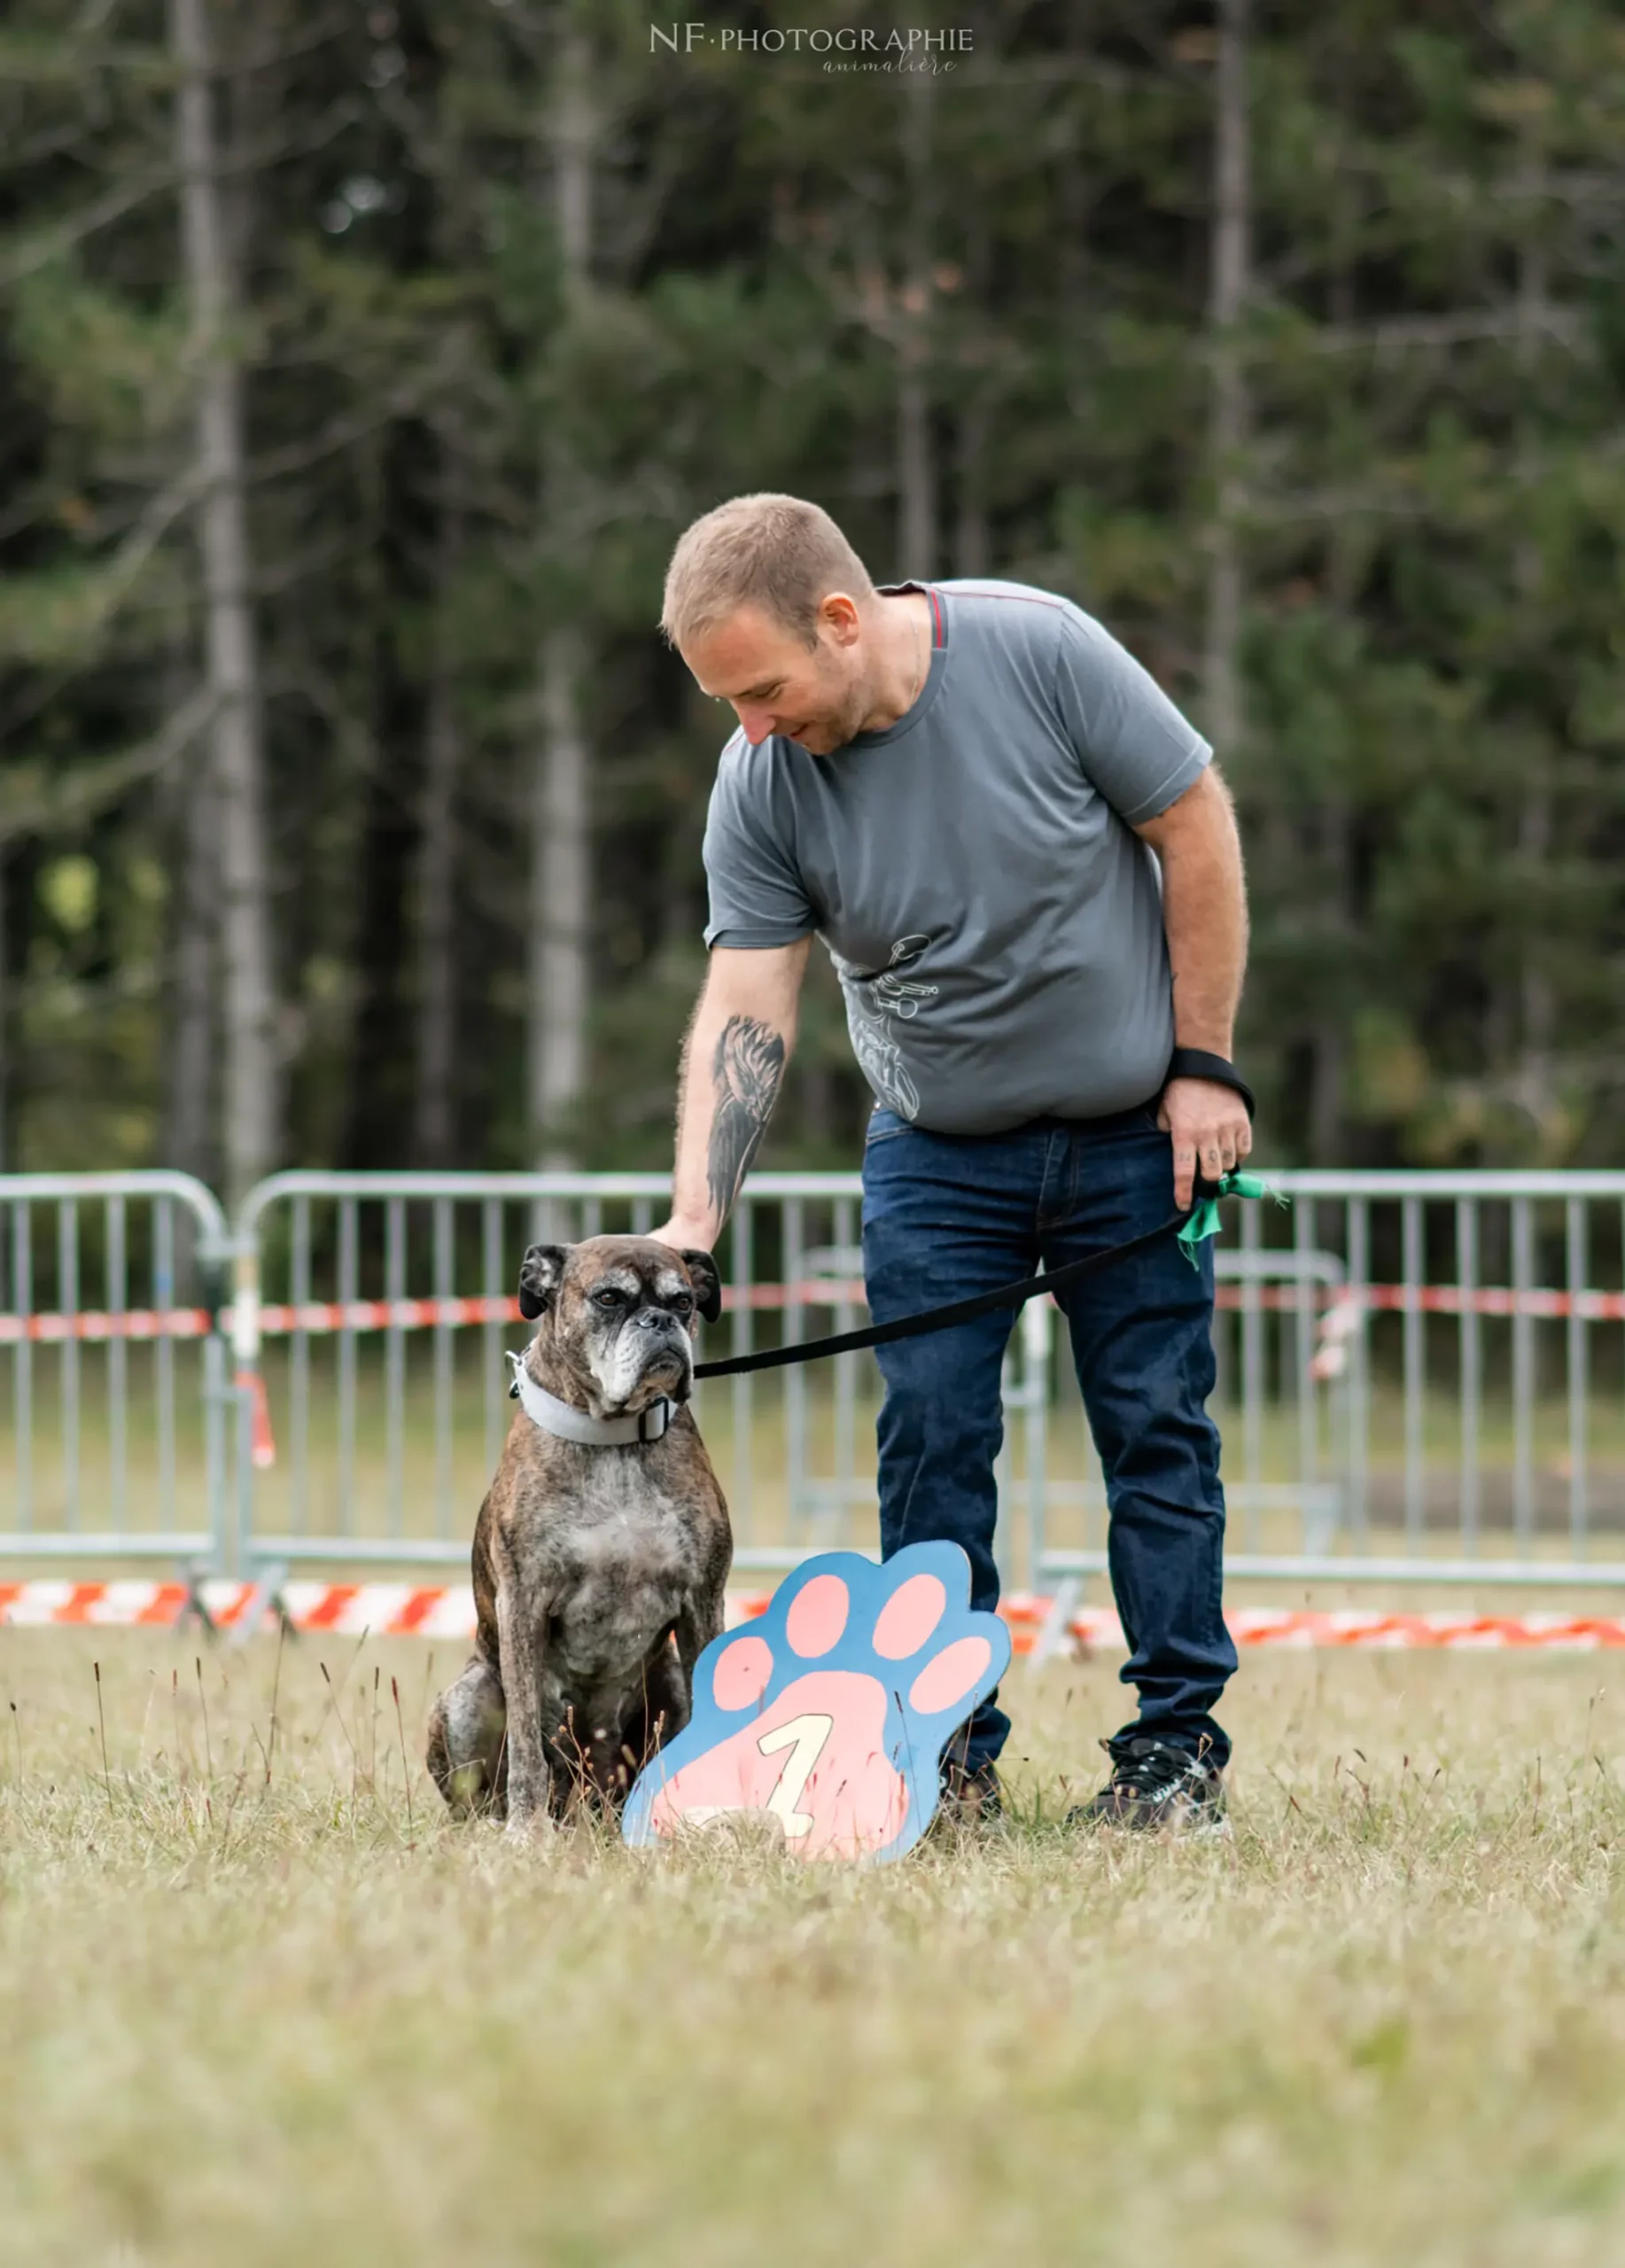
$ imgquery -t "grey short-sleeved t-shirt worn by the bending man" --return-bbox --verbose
[706,580,1212,1134]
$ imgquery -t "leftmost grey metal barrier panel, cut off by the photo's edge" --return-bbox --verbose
[0,1173,236,1560]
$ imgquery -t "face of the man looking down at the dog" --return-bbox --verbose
[683,592,869,755]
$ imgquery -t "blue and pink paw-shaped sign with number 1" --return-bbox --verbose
[622,1542,1010,1860]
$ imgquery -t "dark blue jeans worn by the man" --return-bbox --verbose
[862,1105,1234,1767]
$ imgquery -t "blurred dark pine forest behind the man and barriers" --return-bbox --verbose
[0,0,1625,1191]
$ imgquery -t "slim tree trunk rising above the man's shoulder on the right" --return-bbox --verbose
[1203,0,1250,757]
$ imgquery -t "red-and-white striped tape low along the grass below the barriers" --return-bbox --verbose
[0,1579,1625,1653]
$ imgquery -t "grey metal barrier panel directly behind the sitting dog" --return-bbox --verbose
[234,1173,903,1567]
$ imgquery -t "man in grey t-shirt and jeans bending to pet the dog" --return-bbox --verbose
[658,494,1250,1830]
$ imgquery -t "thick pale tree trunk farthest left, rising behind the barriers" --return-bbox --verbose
[170,0,279,1202]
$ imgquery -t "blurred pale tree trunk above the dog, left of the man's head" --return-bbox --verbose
[526,25,599,1170]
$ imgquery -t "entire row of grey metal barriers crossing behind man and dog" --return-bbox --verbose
[0,1173,1625,1590]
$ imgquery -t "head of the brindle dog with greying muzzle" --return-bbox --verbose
[520,1236,722,1418]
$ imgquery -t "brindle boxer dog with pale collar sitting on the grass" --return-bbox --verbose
[429,1236,733,1832]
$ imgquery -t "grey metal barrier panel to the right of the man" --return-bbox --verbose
[1030,1173,1625,1611]
